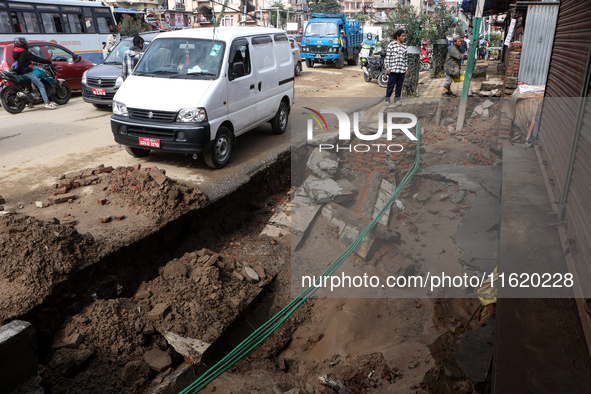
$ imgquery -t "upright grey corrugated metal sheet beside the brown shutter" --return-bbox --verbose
[519,4,558,85]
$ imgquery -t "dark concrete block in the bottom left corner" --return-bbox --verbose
[0,320,37,393]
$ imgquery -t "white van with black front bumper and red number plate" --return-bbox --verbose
[111,27,294,168]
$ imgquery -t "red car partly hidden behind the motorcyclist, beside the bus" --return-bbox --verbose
[0,41,94,90]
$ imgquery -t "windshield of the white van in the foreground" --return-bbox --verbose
[133,38,225,79]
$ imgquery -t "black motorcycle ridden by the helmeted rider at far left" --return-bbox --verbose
[0,64,72,114]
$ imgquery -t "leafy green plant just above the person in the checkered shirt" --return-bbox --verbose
[382,2,427,46]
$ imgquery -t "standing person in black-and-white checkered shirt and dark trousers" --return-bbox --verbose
[384,29,408,105]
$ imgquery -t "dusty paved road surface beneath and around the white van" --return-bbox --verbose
[0,85,376,207]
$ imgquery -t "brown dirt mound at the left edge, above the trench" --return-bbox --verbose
[0,214,99,322]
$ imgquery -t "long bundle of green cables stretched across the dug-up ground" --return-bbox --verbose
[179,121,421,394]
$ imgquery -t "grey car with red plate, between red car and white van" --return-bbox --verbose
[82,32,160,108]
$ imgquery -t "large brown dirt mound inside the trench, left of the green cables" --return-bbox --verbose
[43,242,289,393]
